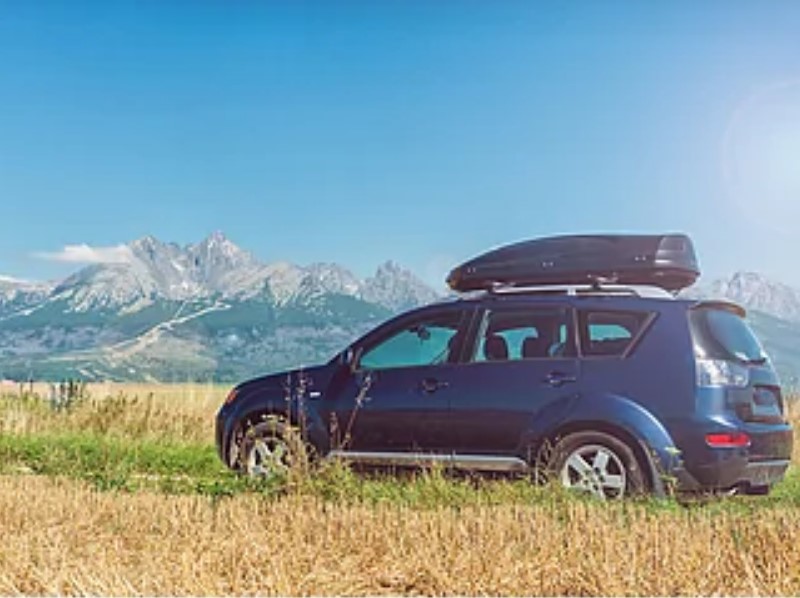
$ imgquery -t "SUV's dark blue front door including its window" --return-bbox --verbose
[331,306,471,453]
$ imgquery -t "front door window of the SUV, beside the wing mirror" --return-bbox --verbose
[359,311,463,370]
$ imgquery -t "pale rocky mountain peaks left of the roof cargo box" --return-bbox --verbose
[17,231,438,313]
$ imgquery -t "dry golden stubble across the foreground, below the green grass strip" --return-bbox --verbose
[0,477,800,595]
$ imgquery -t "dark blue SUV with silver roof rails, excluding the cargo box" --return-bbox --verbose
[216,237,792,498]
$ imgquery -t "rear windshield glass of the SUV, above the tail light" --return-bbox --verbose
[689,307,767,363]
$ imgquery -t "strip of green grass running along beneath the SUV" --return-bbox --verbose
[0,432,800,514]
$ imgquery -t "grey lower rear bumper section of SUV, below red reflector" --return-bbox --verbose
[675,459,789,492]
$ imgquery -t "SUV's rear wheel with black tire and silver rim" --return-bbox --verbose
[550,431,648,500]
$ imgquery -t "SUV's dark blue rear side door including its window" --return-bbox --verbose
[449,302,580,455]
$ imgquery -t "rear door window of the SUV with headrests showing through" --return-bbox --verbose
[472,307,574,362]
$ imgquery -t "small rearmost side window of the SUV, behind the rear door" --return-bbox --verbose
[578,310,650,357]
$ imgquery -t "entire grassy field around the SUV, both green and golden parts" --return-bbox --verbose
[0,385,800,595]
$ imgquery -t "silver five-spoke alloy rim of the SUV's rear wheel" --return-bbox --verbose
[561,444,628,500]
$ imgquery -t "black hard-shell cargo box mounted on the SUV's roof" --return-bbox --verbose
[447,234,700,292]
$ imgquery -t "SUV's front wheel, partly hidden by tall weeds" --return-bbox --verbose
[238,418,308,479]
